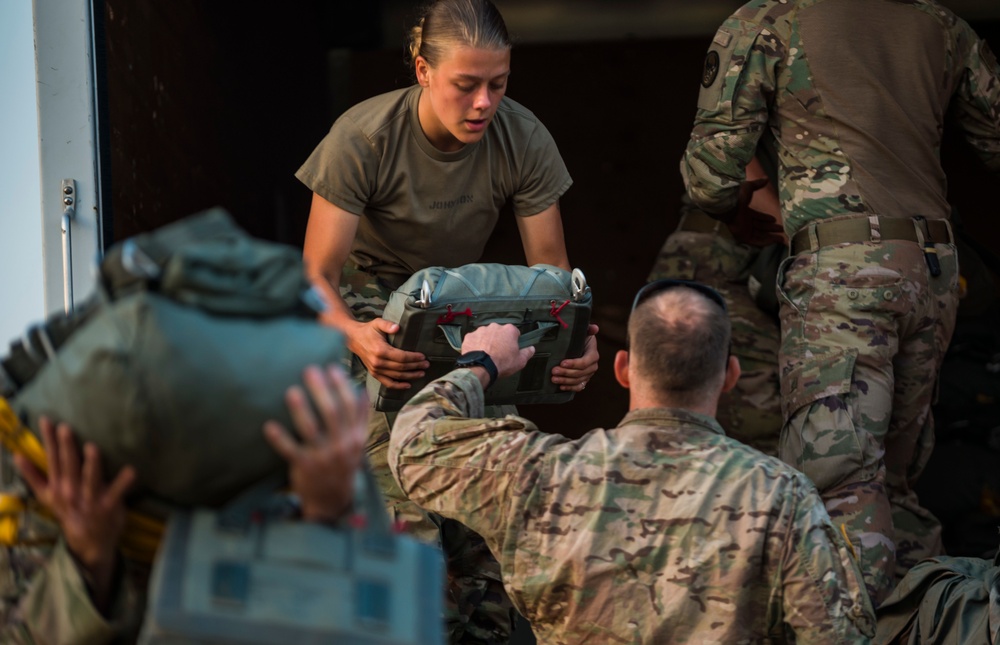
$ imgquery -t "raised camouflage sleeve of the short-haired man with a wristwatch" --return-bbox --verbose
[389,370,546,546]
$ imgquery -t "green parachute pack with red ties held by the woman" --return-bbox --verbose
[368,263,593,411]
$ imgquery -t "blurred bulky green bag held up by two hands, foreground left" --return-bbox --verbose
[0,210,345,505]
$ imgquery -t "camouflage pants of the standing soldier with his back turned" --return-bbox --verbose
[779,235,958,606]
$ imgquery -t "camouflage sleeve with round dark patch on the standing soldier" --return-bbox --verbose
[681,10,784,214]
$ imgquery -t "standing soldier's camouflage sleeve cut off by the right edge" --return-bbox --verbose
[951,28,1000,172]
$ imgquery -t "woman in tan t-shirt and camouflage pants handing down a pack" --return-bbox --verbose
[296,0,598,642]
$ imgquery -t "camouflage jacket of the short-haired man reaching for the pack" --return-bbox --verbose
[389,370,875,644]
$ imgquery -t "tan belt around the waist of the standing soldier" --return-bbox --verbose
[791,216,954,255]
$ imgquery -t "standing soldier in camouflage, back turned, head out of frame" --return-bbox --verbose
[682,0,1000,602]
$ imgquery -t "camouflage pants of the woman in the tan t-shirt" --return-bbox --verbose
[340,268,515,645]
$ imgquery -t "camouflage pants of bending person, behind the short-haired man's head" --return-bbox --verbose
[649,224,782,456]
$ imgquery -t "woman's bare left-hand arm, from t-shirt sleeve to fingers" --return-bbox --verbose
[303,193,429,389]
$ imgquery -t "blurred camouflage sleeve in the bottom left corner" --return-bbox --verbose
[0,484,149,645]
